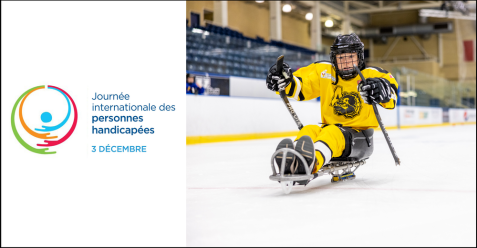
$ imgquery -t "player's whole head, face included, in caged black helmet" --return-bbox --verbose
[330,33,366,80]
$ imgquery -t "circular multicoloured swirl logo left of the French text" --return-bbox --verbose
[11,85,78,154]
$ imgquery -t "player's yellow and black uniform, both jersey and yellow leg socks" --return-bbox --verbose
[278,62,398,173]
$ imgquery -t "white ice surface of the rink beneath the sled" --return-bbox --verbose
[187,125,476,247]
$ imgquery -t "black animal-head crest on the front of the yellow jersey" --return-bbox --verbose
[330,86,363,119]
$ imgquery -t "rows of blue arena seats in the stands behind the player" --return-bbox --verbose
[186,24,328,78]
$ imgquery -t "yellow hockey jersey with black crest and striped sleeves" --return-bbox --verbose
[278,61,398,130]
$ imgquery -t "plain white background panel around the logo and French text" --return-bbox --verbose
[1,1,186,247]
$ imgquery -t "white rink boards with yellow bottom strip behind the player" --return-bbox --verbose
[186,95,476,144]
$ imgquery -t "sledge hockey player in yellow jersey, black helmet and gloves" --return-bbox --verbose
[266,33,398,174]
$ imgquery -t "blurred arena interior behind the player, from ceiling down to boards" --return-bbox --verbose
[186,1,476,144]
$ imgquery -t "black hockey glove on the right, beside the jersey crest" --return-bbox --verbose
[358,78,392,104]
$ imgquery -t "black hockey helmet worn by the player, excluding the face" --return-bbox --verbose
[330,33,366,80]
